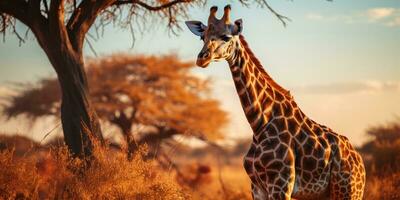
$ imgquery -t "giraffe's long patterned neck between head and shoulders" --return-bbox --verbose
[227,35,292,134]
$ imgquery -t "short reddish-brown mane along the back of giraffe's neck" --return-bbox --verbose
[239,35,291,98]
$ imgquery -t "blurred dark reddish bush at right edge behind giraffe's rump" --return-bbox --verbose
[360,120,400,175]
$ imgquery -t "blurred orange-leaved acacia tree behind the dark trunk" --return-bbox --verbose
[4,54,227,159]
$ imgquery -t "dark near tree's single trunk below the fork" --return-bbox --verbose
[46,48,103,158]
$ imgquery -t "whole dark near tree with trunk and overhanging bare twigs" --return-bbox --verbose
[0,0,287,157]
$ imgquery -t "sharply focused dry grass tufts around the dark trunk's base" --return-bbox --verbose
[0,145,189,199]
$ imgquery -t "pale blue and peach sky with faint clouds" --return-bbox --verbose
[0,0,400,145]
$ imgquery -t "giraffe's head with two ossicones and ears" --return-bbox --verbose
[185,5,243,67]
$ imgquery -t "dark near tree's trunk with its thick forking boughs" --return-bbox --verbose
[0,0,106,158]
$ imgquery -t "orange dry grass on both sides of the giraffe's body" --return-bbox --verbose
[0,131,400,200]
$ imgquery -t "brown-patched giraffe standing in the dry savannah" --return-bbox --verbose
[186,5,365,200]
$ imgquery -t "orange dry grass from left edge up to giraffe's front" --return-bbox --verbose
[0,143,251,200]
